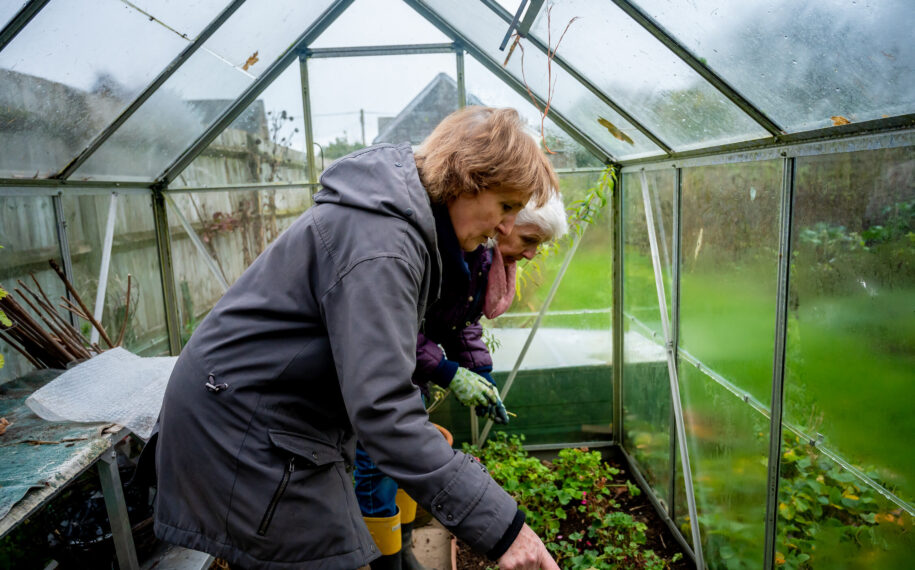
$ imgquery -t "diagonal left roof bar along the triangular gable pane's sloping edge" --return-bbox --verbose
[155,0,354,187]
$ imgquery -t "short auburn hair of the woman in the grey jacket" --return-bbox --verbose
[414,106,559,206]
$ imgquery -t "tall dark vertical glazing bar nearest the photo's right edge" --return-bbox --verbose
[763,157,796,568]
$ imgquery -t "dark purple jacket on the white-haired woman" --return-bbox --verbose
[413,206,492,389]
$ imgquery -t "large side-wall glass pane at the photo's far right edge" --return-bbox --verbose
[784,147,915,496]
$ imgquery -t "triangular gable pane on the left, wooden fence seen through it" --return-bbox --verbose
[170,65,308,188]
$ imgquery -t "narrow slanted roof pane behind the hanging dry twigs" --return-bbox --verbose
[425,0,662,159]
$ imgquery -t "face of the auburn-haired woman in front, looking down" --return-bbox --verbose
[448,190,530,251]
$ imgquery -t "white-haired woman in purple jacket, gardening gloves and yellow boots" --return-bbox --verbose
[354,192,568,570]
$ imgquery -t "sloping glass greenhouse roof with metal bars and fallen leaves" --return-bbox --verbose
[0,0,915,188]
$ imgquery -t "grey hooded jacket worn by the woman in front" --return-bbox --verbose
[155,145,518,569]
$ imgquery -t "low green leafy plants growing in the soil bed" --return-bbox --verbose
[458,433,689,570]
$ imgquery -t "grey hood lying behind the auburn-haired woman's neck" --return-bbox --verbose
[314,143,438,247]
